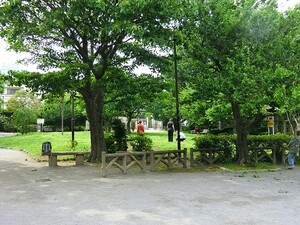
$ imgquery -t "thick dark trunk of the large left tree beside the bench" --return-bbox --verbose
[81,88,106,162]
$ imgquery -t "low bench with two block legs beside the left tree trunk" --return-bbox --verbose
[42,151,90,167]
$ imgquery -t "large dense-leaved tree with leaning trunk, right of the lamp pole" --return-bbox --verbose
[181,0,296,165]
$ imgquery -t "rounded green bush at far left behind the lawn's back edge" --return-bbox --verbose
[12,107,37,134]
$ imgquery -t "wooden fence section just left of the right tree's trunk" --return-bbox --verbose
[190,148,223,167]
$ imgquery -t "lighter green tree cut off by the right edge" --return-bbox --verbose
[274,5,300,134]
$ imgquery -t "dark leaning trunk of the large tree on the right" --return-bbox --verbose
[231,102,251,166]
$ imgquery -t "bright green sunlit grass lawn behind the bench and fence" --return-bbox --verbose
[0,131,196,156]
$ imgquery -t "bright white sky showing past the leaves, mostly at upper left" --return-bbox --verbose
[0,0,300,72]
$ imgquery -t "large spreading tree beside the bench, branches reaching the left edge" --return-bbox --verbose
[0,0,182,162]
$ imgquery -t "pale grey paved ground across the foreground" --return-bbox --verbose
[0,149,300,225]
